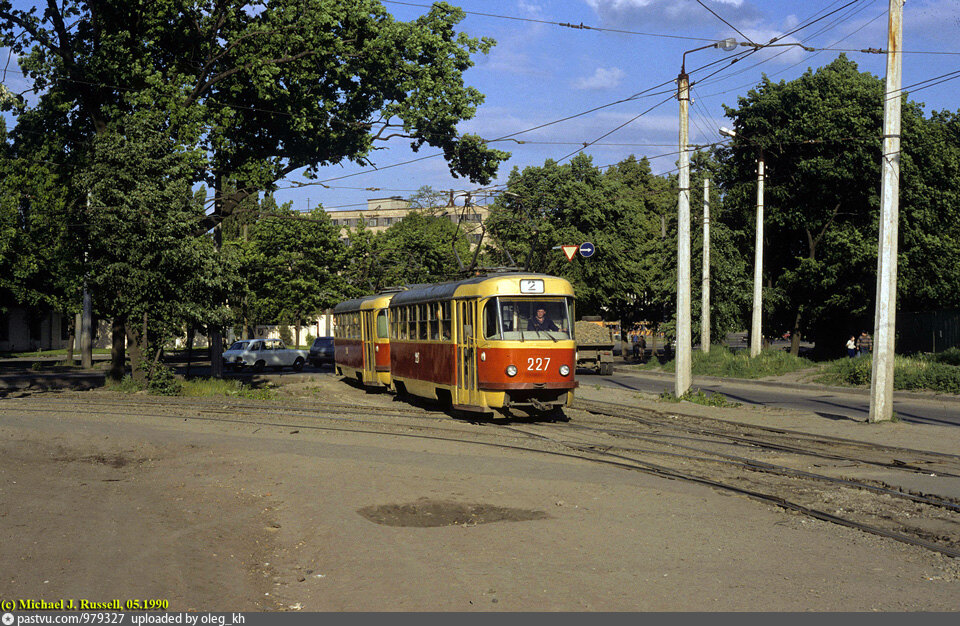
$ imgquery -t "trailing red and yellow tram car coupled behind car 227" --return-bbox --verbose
[333,293,396,387]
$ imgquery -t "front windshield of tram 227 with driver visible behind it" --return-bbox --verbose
[483,298,572,341]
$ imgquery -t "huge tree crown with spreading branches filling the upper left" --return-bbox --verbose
[0,0,508,370]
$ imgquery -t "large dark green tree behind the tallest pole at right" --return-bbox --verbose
[718,55,960,353]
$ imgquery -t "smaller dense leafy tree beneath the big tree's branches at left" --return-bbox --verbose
[81,115,236,380]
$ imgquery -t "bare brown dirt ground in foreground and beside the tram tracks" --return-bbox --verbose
[0,375,960,611]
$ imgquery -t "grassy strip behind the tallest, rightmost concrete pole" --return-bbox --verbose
[816,348,960,394]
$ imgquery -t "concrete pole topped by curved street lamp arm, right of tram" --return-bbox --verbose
[674,68,693,397]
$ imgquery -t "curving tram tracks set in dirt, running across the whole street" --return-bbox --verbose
[3,397,960,558]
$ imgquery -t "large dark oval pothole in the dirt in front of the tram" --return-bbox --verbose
[357,498,550,528]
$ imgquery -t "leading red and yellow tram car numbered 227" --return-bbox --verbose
[388,272,577,413]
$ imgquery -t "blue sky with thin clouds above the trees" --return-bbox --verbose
[4,0,960,210]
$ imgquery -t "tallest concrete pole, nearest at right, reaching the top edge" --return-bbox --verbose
[870,0,904,422]
